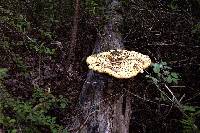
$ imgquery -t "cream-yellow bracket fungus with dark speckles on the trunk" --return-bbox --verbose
[86,49,151,79]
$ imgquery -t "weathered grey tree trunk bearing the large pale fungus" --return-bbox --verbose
[79,0,131,133]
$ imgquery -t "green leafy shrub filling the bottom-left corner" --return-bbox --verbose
[0,72,67,133]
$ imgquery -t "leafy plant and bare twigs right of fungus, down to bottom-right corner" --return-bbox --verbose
[146,61,200,133]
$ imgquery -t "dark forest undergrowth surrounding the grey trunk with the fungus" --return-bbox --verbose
[0,0,200,133]
